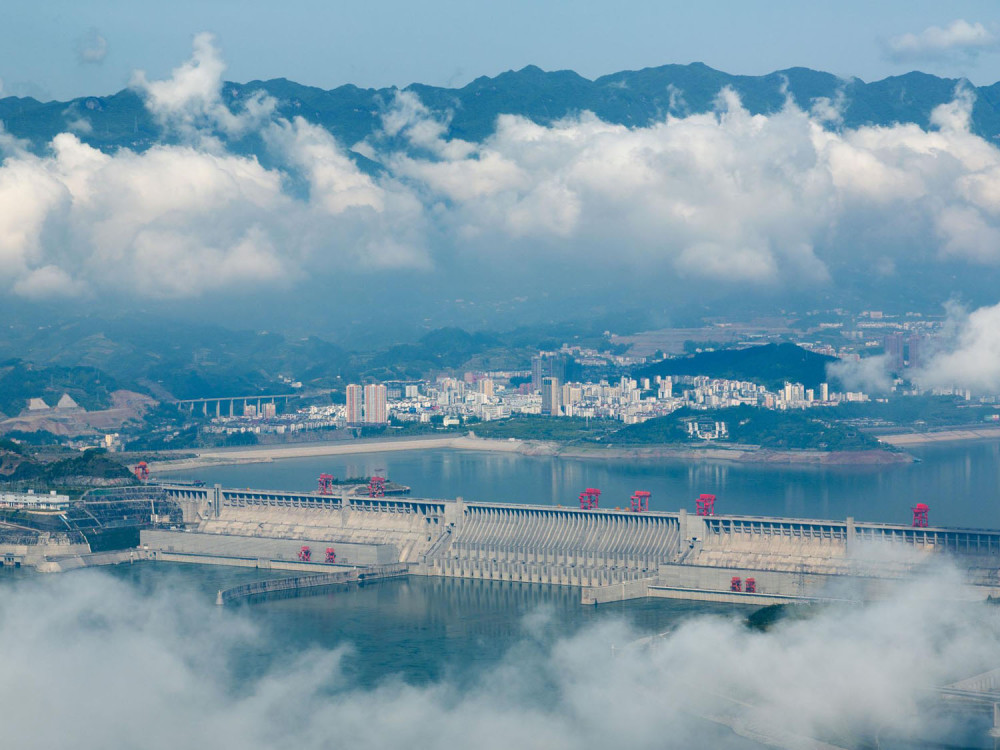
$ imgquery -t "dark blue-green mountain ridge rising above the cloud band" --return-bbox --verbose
[0,63,1000,159]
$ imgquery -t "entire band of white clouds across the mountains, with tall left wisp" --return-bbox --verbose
[7,34,1000,304]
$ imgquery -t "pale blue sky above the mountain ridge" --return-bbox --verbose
[0,0,1000,99]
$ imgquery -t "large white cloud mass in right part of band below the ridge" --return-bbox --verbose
[382,82,1000,284]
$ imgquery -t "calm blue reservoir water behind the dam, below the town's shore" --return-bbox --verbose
[174,442,1000,528]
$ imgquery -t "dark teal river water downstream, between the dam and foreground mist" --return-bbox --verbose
[97,563,753,687]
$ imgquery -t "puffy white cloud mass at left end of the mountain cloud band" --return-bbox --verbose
[0,126,425,297]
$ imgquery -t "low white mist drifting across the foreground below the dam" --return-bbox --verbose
[0,569,1000,750]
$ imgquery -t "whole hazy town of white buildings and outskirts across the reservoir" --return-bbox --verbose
[186,310,996,450]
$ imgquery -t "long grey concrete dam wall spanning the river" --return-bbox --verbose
[133,485,1000,604]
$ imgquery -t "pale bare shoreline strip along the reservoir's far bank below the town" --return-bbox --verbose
[150,434,913,474]
